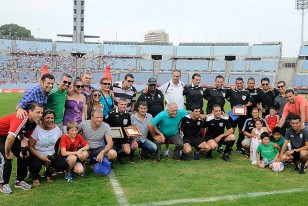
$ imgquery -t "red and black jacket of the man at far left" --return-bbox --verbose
[0,113,36,139]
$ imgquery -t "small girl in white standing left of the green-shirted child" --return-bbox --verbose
[250,119,268,165]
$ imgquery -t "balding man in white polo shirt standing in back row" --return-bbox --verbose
[158,70,184,109]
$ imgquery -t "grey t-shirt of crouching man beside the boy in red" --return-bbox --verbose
[78,120,112,149]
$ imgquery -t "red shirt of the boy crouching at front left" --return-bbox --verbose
[60,134,88,154]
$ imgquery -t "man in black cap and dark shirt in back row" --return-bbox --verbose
[135,78,164,117]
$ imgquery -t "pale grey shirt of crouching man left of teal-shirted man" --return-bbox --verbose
[130,113,153,143]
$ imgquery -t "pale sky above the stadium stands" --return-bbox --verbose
[0,0,308,57]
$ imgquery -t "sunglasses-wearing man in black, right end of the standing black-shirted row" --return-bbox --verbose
[256,77,279,118]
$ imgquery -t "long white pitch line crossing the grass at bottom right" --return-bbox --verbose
[131,188,308,206]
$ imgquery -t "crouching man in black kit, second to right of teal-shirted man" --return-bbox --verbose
[205,104,235,162]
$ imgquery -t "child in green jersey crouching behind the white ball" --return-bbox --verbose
[257,132,279,169]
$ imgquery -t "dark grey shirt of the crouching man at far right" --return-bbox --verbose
[285,127,308,149]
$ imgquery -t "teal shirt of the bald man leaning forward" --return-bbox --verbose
[151,109,188,136]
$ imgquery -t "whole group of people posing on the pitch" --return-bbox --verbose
[0,70,308,194]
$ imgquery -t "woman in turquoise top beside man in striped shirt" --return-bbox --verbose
[100,77,114,120]
